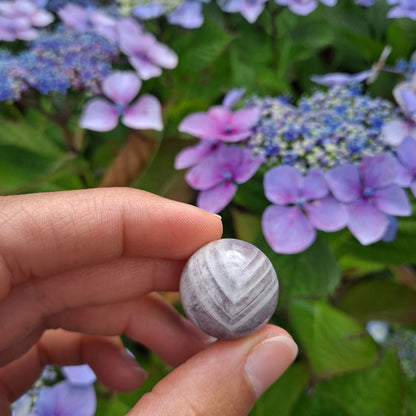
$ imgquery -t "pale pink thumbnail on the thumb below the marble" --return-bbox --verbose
[245,335,298,397]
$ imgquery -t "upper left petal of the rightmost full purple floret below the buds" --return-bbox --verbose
[326,164,361,202]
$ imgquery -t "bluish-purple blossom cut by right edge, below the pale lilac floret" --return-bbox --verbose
[396,136,416,196]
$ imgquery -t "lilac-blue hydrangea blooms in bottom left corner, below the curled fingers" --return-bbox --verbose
[13,365,97,416]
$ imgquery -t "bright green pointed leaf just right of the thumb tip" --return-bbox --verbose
[290,300,378,377]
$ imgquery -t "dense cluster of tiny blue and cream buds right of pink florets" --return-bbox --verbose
[248,86,397,172]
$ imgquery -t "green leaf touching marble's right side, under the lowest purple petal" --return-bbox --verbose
[256,235,341,297]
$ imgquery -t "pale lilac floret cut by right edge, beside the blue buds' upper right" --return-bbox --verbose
[382,82,416,146]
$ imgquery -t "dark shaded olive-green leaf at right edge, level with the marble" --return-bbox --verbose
[338,280,416,325]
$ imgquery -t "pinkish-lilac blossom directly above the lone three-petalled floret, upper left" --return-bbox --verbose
[117,18,178,80]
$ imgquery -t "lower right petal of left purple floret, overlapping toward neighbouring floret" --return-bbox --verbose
[304,196,348,232]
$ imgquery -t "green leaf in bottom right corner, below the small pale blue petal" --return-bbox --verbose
[312,350,404,416]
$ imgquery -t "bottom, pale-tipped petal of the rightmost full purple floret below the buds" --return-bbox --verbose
[348,199,389,246]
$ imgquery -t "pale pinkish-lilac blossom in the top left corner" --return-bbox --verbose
[0,0,54,42]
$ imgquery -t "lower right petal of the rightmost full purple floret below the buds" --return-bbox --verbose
[372,184,412,216]
